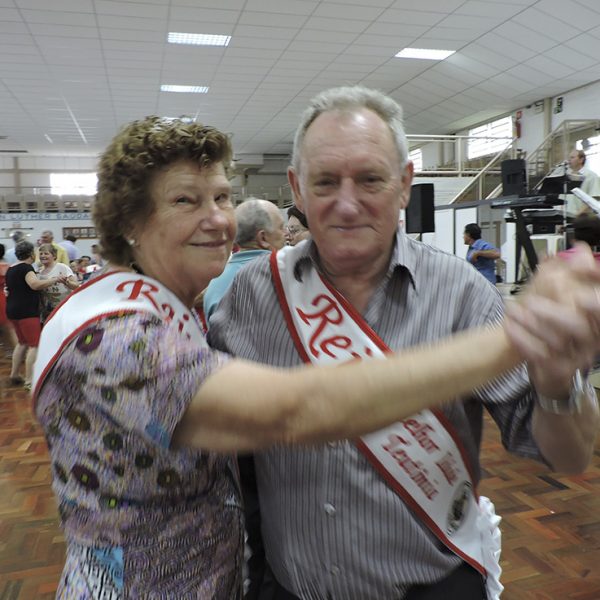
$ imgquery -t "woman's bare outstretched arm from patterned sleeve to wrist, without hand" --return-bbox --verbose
[173,327,520,452]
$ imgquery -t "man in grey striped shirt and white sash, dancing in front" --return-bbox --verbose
[210,87,600,600]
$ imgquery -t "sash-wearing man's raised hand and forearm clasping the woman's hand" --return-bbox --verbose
[506,244,600,473]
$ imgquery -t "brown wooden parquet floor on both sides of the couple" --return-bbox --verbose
[0,347,600,600]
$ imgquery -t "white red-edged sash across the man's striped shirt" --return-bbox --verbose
[271,247,503,600]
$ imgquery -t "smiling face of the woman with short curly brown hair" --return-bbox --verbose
[132,160,236,306]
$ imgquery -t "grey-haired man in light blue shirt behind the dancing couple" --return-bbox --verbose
[204,198,285,322]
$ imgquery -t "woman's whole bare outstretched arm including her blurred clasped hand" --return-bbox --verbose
[173,249,600,451]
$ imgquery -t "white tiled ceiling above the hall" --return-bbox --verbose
[0,0,600,157]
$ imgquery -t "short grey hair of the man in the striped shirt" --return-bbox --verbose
[292,85,408,173]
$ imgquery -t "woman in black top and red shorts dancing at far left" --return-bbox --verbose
[5,241,63,389]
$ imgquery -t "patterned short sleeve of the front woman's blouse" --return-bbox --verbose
[44,313,227,448]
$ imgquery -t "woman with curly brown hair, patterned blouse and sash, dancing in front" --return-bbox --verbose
[34,117,600,600]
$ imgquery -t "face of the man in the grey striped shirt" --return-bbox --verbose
[288,109,413,275]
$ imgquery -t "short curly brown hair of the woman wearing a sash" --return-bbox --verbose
[93,116,233,265]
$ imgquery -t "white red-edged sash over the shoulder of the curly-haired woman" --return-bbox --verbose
[32,271,208,401]
